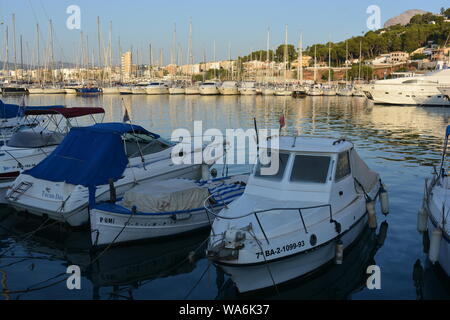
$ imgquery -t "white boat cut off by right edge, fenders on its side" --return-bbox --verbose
[417,126,450,277]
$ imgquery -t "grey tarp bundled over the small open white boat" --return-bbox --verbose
[122,179,209,213]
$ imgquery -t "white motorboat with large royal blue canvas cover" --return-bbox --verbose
[6,123,209,227]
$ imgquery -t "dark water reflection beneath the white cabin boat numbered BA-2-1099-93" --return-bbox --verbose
[216,221,388,300]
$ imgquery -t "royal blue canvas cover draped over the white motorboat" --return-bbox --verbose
[24,123,153,189]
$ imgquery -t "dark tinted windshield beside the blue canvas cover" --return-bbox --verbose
[123,133,171,158]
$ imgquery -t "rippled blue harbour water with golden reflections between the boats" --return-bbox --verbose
[0,95,450,299]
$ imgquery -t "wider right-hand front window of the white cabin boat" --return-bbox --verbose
[291,155,331,183]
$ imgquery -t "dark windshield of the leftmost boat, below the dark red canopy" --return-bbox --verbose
[6,130,65,148]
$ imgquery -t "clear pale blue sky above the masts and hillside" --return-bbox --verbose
[0,0,450,64]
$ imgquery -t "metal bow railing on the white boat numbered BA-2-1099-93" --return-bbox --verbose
[204,195,341,244]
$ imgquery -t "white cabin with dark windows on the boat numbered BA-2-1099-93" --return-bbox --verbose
[246,137,378,208]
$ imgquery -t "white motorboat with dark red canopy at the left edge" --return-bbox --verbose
[0,106,105,203]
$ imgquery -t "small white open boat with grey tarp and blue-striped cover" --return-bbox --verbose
[90,175,248,246]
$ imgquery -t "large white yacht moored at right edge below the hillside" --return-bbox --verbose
[361,63,450,106]
